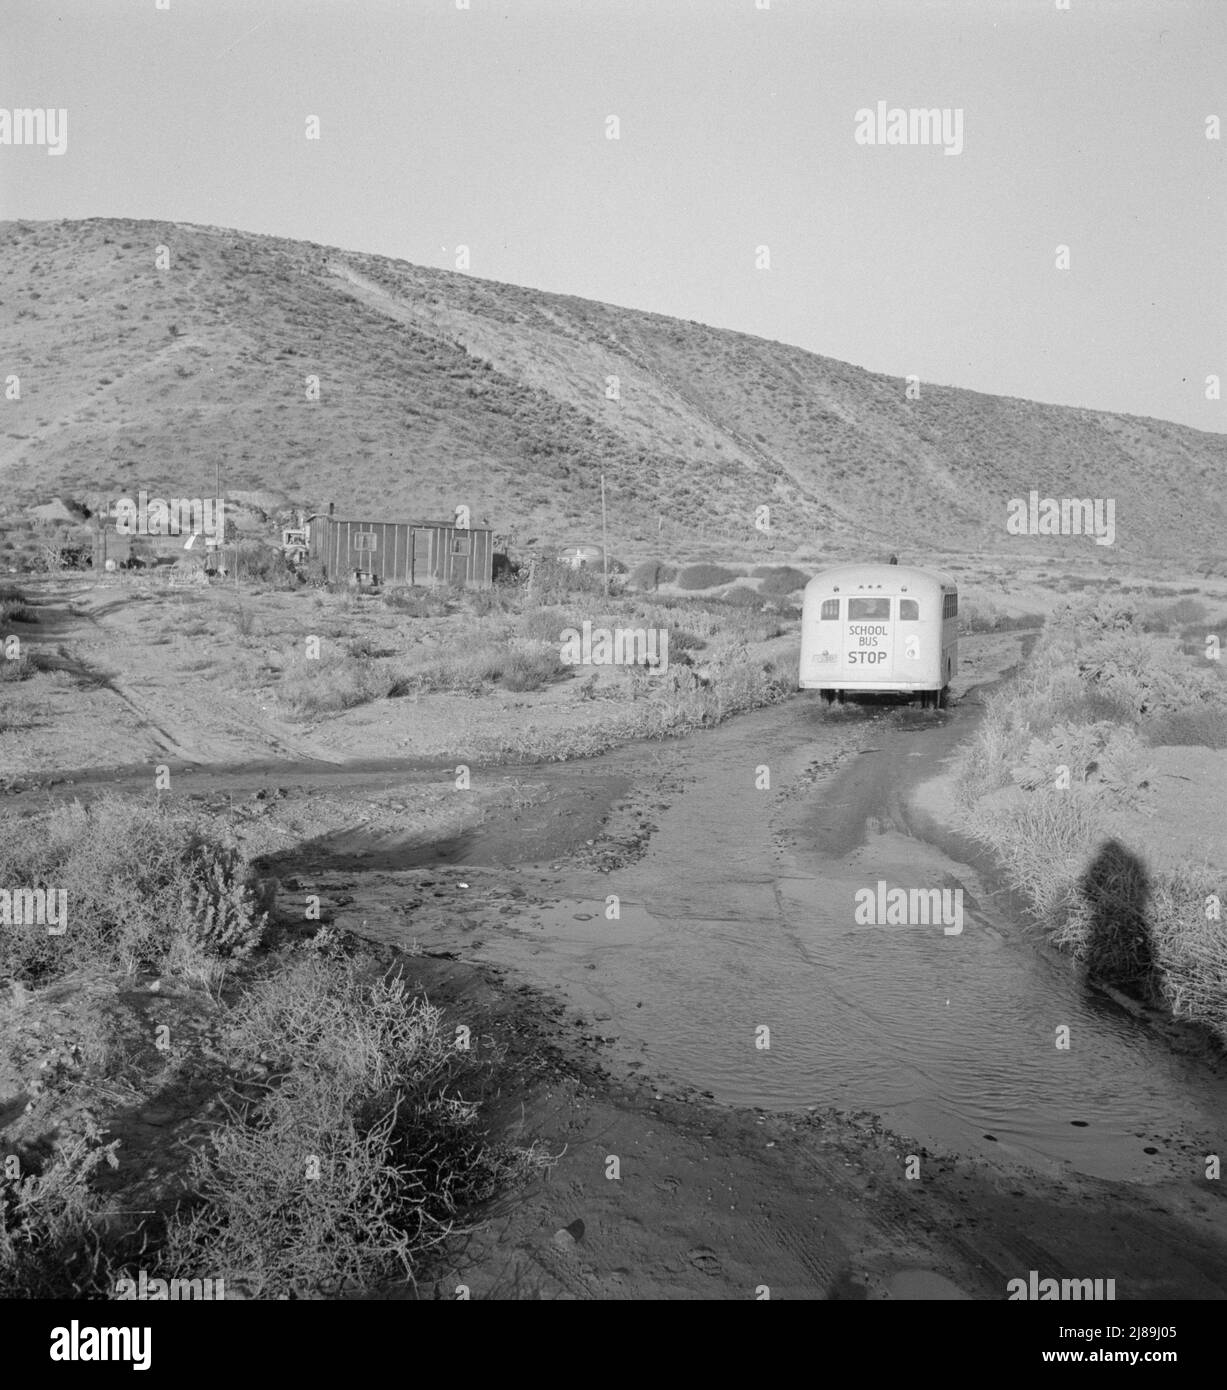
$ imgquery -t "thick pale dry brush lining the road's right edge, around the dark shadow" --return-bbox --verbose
[955,599,1227,1037]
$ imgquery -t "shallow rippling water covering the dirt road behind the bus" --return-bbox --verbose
[464,702,1227,1177]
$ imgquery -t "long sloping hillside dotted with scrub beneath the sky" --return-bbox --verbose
[0,220,1227,559]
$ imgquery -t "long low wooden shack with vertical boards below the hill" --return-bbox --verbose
[307,513,495,589]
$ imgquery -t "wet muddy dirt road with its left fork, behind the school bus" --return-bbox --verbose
[14,636,1227,1298]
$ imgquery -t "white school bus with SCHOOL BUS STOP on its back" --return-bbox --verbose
[800,564,959,709]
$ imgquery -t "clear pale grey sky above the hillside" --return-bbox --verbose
[0,0,1227,431]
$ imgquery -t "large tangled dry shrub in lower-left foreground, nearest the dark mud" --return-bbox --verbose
[164,952,547,1298]
